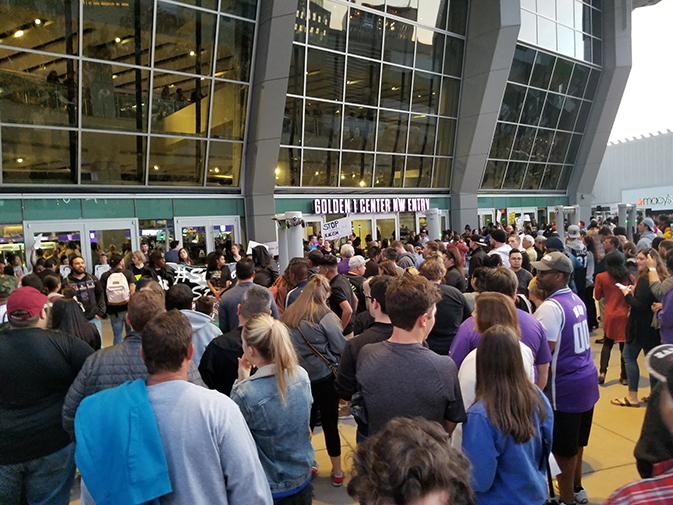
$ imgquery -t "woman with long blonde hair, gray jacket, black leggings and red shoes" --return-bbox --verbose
[281,275,346,486]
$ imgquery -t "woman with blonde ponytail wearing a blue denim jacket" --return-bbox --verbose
[231,314,314,505]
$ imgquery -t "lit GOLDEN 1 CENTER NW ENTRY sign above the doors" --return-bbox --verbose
[313,198,430,215]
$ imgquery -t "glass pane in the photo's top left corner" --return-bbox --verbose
[0,0,79,54]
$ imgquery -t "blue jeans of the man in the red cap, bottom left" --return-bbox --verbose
[0,443,75,505]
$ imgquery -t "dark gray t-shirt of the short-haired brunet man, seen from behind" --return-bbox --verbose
[355,341,467,436]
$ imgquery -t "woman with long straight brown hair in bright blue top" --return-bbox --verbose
[462,324,553,505]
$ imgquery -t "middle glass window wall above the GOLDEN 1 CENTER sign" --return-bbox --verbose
[275,0,468,189]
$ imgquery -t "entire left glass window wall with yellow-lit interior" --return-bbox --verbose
[0,0,257,187]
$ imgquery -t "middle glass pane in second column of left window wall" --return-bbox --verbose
[82,61,147,132]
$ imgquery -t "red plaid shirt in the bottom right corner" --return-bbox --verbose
[605,459,673,505]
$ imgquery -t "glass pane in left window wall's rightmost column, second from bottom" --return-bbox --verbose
[210,81,249,140]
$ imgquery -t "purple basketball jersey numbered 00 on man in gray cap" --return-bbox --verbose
[547,289,599,413]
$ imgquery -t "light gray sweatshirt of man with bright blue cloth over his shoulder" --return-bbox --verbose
[147,380,273,505]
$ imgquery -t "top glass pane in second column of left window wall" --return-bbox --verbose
[82,0,154,66]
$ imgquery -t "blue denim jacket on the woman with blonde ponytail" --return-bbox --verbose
[231,364,314,494]
